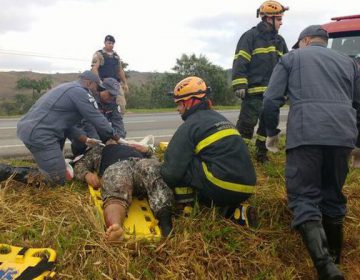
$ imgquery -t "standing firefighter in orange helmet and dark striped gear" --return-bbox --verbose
[232,1,289,163]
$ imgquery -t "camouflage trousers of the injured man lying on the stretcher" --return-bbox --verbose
[102,159,174,215]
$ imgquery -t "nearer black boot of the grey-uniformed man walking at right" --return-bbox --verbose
[298,221,344,280]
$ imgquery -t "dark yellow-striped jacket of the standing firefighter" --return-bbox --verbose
[232,21,288,95]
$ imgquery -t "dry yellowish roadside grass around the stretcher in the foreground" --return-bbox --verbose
[0,143,360,280]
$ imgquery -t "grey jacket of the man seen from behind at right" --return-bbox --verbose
[263,44,360,149]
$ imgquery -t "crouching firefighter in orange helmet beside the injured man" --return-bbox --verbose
[161,76,256,226]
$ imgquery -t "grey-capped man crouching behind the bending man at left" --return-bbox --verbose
[68,78,126,156]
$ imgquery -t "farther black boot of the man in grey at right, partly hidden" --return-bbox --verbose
[322,215,344,264]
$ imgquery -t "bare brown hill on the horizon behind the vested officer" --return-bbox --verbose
[0,71,155,98]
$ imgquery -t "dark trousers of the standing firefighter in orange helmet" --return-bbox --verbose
[236,95,267,153]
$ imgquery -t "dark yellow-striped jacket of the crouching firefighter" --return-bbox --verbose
[161,103,256,194]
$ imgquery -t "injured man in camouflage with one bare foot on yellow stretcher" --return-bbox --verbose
[74,140,174,241]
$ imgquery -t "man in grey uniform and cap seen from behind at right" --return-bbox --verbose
[263,25,360,279]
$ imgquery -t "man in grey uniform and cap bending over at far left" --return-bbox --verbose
[17,71,118,185]
